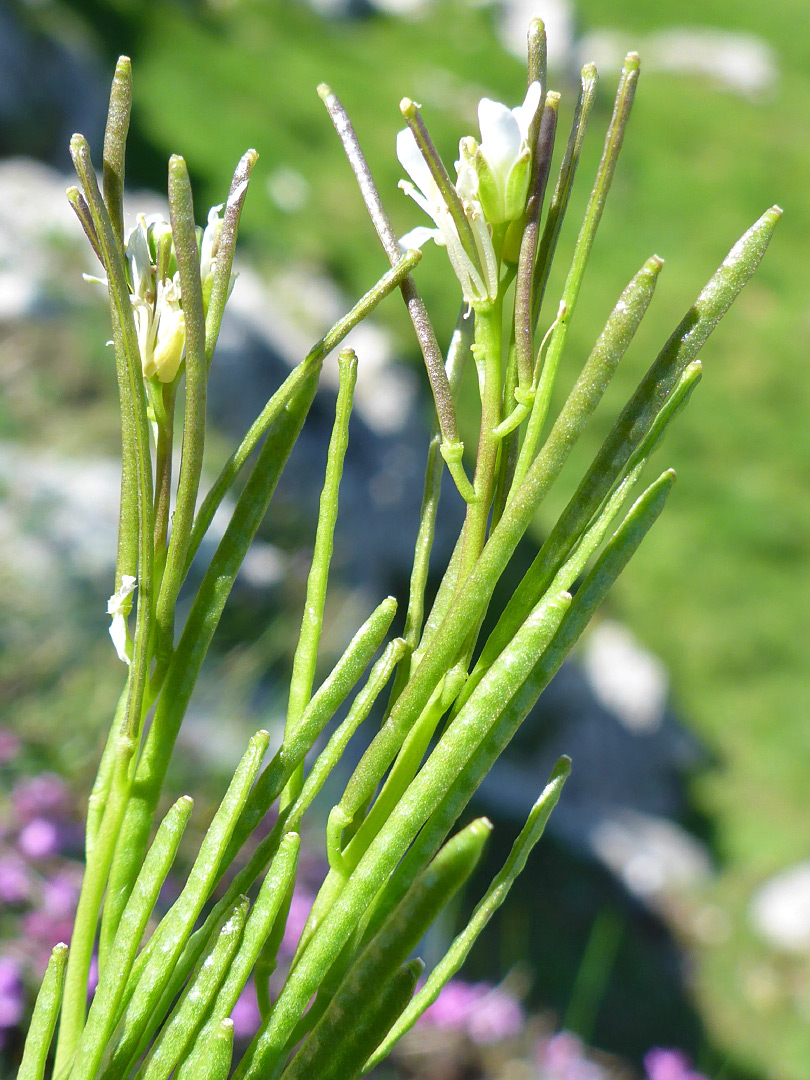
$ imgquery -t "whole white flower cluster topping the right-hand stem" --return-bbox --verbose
[396,82,541,303]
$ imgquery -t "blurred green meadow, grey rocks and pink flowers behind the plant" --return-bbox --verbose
[0,0,810,1080]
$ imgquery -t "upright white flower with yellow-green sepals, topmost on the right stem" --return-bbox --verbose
[456,82,541,225]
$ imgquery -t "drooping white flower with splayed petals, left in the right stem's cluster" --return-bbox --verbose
[396,127,498,303]
